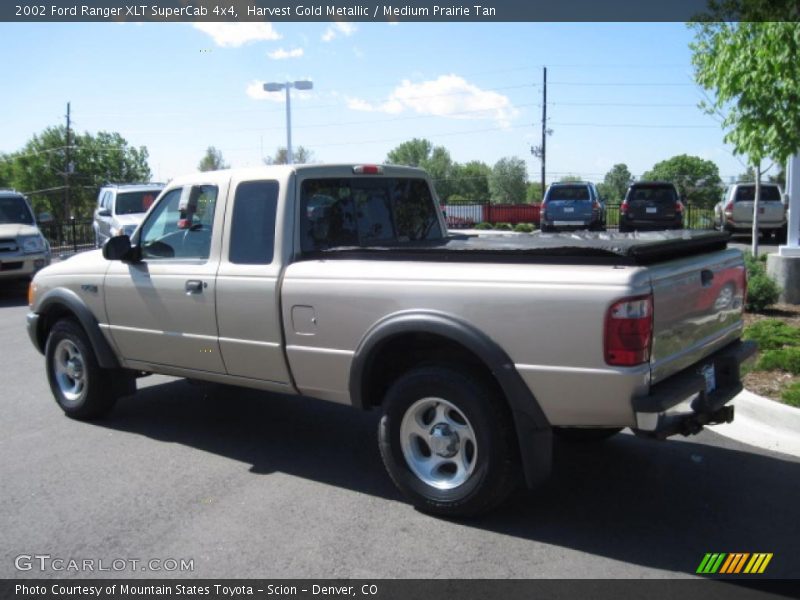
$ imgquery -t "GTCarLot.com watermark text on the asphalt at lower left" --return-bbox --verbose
[14,554,194,573]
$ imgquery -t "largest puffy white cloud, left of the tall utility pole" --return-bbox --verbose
[347,75,519,127]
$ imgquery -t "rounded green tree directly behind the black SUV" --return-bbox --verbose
[640,154,722,208]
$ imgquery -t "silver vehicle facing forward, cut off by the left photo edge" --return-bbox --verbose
[0,190,52,280]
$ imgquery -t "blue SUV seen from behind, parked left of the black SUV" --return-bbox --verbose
[539,182,606,233]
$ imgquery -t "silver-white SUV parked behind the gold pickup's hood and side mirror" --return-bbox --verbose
[92,183,164,248]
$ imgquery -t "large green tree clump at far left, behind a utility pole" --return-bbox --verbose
[0,126,151,219]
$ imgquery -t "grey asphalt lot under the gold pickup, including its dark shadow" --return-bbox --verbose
[0,288,800,578]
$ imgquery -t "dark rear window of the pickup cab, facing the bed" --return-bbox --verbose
[300,177,444,252]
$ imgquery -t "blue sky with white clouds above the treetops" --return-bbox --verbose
[0,23,764,181]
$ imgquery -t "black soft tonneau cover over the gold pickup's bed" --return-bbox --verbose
[305,230,730,265]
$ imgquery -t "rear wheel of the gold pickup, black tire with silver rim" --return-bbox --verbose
[378,366,519,517]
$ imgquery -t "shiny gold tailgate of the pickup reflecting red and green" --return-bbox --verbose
[650,249,746,383]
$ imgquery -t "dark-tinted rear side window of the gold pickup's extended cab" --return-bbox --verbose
[229,181,278,265]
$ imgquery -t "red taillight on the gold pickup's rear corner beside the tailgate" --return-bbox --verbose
[604,295,653,367]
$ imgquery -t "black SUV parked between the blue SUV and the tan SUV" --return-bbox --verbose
[619,181,684,232]
